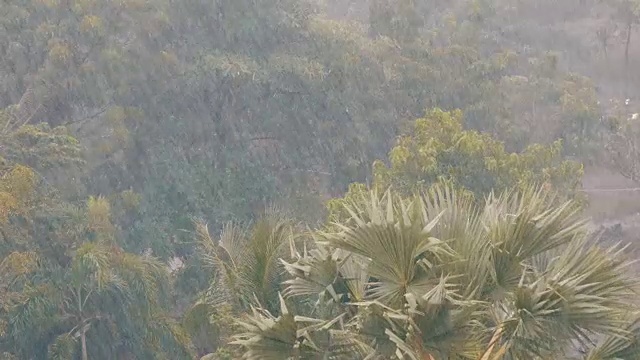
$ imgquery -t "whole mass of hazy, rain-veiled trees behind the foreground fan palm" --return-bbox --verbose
[0,0,638,358]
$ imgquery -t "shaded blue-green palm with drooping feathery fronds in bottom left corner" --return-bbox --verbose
[5,242,192,360]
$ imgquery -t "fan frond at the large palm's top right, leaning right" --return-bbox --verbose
[470,187,587,297]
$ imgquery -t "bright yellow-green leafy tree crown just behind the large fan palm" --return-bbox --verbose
[329,109,582,222]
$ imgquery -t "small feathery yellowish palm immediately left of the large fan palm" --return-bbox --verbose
[184,210,293,356]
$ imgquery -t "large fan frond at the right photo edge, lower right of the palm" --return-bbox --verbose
[494,239,636,358]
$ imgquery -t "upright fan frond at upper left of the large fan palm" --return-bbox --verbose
[324,192,452,308]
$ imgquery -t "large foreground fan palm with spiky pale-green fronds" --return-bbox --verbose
[234,187,640,360]
